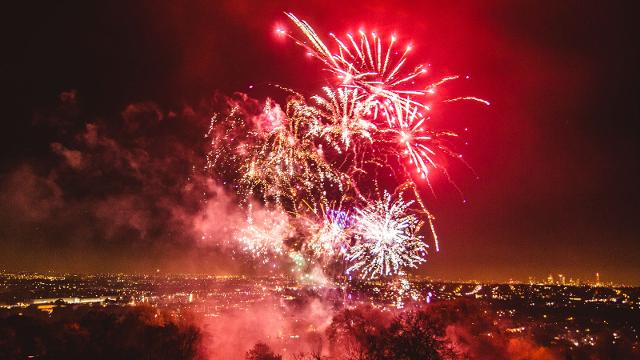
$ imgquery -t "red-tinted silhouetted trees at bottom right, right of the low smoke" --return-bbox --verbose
[242,299,640,360]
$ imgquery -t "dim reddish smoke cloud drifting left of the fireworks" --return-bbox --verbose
[0,91,273,272]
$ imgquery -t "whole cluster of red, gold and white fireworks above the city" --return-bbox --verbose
[202,14,488,292]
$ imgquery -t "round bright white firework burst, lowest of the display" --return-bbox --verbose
[346,192,428,279]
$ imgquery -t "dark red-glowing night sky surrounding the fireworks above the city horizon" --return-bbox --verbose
[0,0,640,284]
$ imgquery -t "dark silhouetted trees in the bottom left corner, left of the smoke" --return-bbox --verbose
[0,306,201,359]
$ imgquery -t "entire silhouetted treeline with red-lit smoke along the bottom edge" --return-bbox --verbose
[0,300,640,360]
